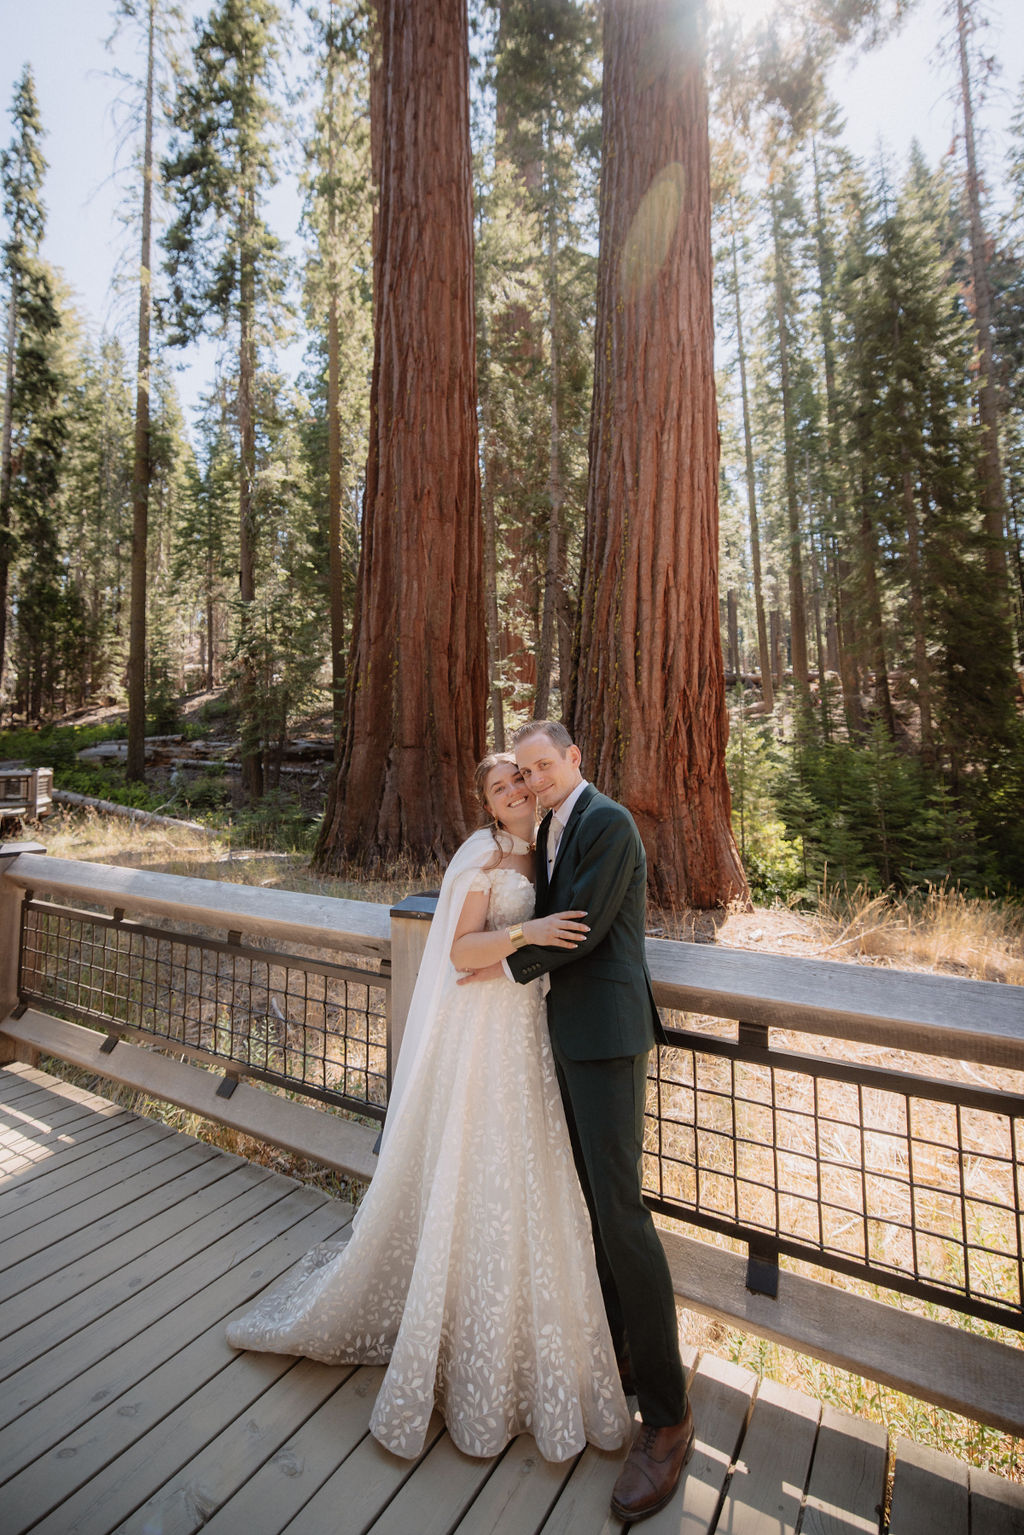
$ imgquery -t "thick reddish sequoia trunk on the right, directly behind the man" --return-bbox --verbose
[571,0,746,907]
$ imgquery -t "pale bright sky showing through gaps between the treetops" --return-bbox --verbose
[0,0,1024,423]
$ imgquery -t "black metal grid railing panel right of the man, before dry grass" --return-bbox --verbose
[645,1028,1024,1329]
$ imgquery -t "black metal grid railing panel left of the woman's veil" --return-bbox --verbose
[20,900,390,1119]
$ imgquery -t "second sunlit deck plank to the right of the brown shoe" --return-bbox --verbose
[718,1380,821,1535]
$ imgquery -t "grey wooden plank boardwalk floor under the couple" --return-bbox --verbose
[0,1064,1024,1535]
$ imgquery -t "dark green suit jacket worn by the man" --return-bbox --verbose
[508,784,663,1061]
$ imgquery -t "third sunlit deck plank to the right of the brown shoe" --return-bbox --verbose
[800,1406,889,1535]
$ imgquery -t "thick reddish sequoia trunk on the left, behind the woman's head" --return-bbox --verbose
[318,0,487,866]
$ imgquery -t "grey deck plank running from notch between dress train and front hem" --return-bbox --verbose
[203,1365,384,1535]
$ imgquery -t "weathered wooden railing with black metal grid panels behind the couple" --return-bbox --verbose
[0,846,1024,1434]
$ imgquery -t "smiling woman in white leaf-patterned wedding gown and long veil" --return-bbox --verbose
[227,754,631,1461]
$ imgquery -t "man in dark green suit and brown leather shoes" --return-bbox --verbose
[505,720,694,1520]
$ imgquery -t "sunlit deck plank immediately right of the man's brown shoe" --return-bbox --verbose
[643,1354,757,1535]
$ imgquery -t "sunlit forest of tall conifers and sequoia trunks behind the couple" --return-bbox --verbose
[0,0,1024,906]
